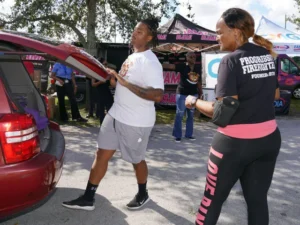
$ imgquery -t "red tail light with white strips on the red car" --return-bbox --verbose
[0,114,40,164]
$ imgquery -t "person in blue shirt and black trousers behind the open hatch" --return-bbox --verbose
[51,63,87,122]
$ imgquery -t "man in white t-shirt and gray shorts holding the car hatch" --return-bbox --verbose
[63,19,164,210]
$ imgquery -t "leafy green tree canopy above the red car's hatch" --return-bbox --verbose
[0,0,179,47]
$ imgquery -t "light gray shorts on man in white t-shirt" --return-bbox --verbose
[97,114,152,164]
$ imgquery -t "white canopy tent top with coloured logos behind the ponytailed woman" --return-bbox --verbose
[256,16,300,56]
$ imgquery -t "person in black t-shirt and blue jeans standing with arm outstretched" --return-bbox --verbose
[163,52,202,142]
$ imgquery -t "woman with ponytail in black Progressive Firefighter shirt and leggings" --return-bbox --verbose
[186,8,281,225]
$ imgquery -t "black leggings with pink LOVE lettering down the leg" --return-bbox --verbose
[196,129,281,225]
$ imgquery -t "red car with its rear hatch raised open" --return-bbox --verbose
[0,30,107,222]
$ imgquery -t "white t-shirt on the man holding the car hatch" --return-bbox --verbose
[108,50,164,127]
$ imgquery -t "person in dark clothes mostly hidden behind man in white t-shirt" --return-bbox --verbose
[92,58,116,124]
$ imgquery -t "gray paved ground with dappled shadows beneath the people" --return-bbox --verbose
[3,118,300,225]
